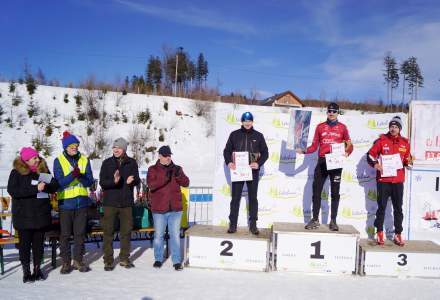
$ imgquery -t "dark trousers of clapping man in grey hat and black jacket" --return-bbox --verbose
[102,206,133,264]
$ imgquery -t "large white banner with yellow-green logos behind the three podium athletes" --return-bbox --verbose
[213,103,406,237]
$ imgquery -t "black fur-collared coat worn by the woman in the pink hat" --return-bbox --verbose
[8,157,58,230]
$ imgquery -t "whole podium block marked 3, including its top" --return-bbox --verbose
[360,240,440,278]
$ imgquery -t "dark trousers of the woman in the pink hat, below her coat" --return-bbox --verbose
[18,229,44,266]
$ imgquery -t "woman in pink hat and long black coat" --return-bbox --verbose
[8,147,58,282]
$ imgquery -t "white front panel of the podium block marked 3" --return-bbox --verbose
[364,248,440,278]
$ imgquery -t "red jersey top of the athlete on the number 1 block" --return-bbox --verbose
[306,121,353,157]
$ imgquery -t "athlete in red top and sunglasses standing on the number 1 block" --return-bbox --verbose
[297,102,353,231]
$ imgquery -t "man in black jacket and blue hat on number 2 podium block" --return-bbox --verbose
[223,112,269,235]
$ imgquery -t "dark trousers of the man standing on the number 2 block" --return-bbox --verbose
[229,171,259,225]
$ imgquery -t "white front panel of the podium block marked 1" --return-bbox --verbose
[277,232,357,274]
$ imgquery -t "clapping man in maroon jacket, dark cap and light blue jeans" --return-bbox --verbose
[147,146,189,271]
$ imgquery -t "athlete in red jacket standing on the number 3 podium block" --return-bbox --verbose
[367,116,411,246]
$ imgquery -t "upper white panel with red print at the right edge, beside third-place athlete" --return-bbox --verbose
[410,101,440,165]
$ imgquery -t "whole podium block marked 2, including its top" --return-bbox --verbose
[184,225,271,272]
